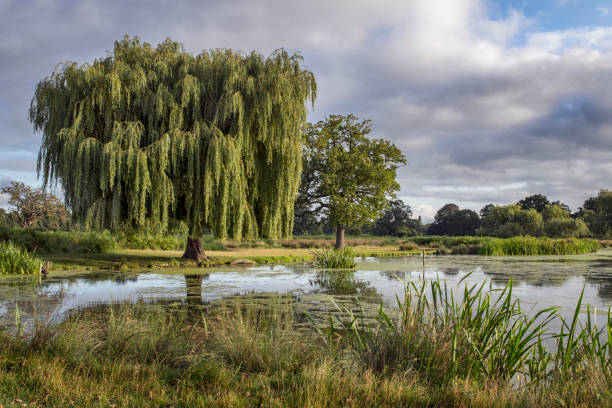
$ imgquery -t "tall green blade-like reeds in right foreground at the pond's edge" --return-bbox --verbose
[317,280,612,388]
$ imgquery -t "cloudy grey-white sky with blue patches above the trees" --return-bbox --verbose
[0,0,612,219]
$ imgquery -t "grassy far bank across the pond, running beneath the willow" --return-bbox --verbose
[0,227,607,270]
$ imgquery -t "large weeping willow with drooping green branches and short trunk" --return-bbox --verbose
[29,36,316,259]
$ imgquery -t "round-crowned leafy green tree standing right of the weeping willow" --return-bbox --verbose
[296,115,406,249]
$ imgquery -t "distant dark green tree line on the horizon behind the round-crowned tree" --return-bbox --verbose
[294,190,612,238]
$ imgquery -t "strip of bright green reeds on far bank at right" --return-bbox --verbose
[480,237,599,256]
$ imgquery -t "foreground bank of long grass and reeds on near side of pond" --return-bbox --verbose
[0,282,612,407]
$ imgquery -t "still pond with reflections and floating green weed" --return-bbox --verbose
[0,251,612,329]
